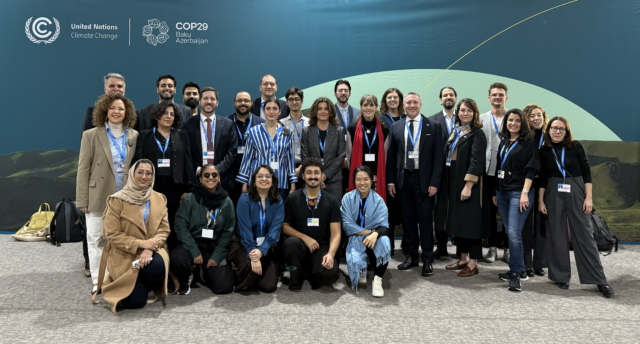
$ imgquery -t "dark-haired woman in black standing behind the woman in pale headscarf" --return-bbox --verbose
[134,100,197,251]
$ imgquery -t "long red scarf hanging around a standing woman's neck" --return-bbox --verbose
[349,118,387,202]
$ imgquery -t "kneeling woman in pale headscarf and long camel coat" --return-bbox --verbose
[92,159,170,315]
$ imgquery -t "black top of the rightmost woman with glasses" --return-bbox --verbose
[540,141,592,187]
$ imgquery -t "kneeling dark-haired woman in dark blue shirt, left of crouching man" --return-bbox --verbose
[228,165,284,295]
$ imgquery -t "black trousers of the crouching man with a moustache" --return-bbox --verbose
[282,237,340,290]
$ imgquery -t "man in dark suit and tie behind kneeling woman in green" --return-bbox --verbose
[184,87,238,190]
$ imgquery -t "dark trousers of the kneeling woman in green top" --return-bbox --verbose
[169,240,234,294]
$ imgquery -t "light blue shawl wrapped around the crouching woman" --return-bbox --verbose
[340,189,391,293]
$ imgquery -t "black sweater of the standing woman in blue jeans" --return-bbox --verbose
[495,138,540,192]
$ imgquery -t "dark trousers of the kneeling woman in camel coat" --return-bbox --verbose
[122,252,165,309]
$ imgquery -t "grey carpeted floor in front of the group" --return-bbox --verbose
[0,235,640,343]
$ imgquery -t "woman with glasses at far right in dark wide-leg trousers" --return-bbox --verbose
[538,117,615,298]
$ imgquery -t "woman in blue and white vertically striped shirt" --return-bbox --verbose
[236,99,298,200]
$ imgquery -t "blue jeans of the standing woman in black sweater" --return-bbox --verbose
[496,191,533,274]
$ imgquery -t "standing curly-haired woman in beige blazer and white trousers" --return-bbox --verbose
[76,92,138,294]
